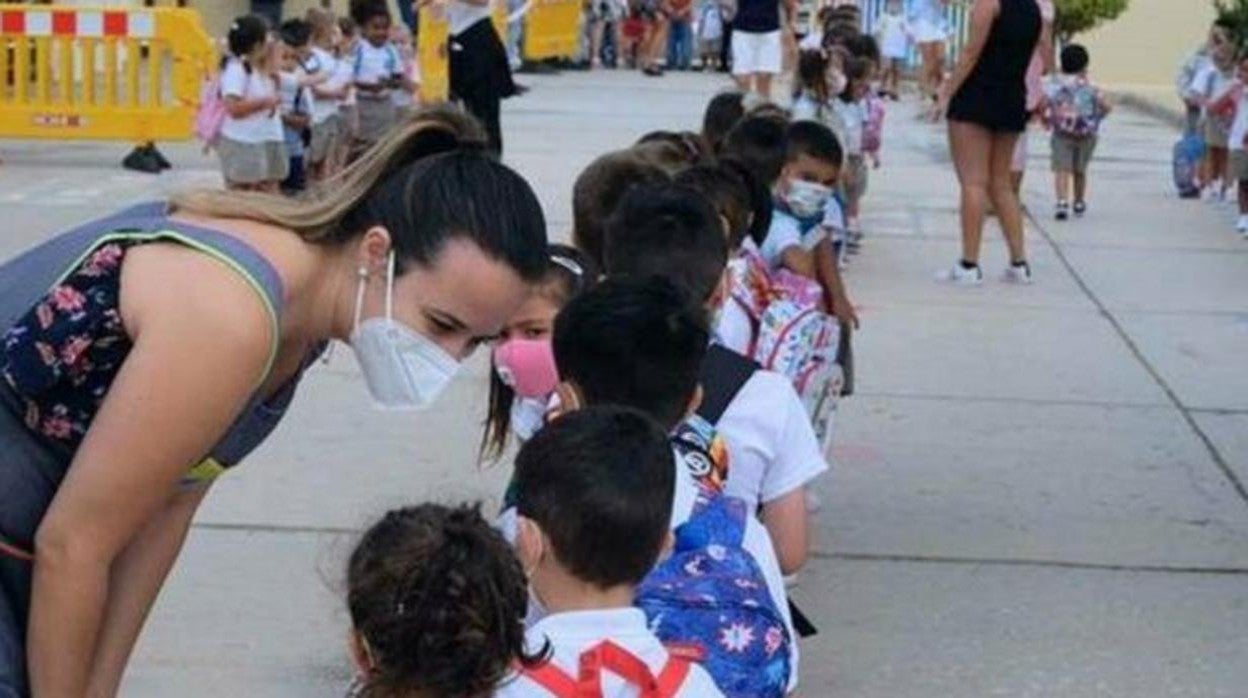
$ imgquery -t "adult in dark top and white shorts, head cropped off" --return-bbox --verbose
[731,0,797,100]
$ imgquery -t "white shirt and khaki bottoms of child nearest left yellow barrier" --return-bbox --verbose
[216,59,290,185]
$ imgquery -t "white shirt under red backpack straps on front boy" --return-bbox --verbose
[494,608,724,698]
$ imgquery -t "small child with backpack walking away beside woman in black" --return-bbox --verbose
[1048,44,1111,221]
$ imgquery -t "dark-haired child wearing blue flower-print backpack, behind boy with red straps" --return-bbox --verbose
[549,277,799,698]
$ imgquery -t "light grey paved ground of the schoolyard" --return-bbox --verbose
[0,66,1248,698]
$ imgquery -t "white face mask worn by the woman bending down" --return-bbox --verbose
[351,252,459,411]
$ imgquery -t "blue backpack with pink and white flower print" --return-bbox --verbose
[635,494,792,698]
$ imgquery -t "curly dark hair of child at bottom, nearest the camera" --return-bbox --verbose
[347,504,548,698]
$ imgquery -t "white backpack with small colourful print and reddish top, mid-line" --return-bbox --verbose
[729,252,845,447]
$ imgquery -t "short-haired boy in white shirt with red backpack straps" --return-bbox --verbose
[494,407,724,698]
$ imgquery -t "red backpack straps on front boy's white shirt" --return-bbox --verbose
[517,639,690,698]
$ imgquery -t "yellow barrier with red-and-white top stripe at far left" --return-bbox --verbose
[0,4,217,144]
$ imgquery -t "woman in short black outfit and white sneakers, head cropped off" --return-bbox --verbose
[940,0,1041,285]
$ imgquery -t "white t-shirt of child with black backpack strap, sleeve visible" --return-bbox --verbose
[715,371,827,511]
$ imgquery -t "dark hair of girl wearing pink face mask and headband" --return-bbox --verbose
[480,243,599,461]
